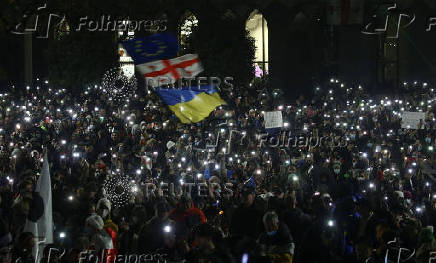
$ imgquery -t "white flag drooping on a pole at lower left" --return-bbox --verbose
[24,153,53,262]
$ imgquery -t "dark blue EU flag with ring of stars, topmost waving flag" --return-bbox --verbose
[123,33,179,65]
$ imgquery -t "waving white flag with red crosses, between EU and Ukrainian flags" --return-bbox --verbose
[136,54,203,87]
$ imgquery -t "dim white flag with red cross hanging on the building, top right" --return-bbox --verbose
[327,0,365,25]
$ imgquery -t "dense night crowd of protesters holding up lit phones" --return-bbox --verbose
[0,79,436,263]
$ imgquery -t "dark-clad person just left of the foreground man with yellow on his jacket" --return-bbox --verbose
[230,187,262,239]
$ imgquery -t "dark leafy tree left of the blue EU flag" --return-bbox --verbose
[46,0,123,92]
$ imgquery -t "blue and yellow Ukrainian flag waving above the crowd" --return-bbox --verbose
[155,86,226,123]
